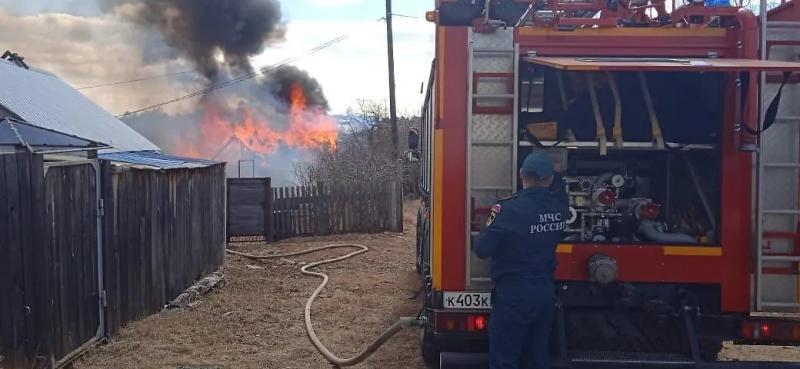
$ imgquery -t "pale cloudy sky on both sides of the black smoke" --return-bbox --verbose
[0,0,434,115]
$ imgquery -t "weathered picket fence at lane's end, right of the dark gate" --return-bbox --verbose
[272,182,403,239]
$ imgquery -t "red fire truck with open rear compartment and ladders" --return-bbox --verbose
[417,0,800,368]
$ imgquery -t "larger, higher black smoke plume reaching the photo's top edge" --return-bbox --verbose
[108,0,285,80]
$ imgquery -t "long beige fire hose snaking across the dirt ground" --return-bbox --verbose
[226,244,424,366]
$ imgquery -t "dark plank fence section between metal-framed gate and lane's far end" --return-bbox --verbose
[103,163,225,334]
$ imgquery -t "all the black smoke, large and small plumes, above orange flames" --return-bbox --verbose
[105,0,329,110]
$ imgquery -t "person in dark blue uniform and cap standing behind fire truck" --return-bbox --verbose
[474,152,569,369]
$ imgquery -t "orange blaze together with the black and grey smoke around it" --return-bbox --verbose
[105,0,339,182]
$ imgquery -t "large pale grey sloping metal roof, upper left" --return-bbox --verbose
[0,59,158,151]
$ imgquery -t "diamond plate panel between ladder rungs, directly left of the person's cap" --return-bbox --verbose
[470,146,512,187]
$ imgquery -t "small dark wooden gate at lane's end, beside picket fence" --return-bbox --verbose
[227,178,273,242]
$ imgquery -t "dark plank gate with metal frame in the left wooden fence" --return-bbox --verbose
[44,160,105,362]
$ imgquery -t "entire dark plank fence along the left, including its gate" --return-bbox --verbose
[0,152,225,369]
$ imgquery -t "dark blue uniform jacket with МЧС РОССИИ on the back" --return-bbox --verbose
[474,175,569,283]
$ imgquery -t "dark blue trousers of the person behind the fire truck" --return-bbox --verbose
[489,276,555,369]
